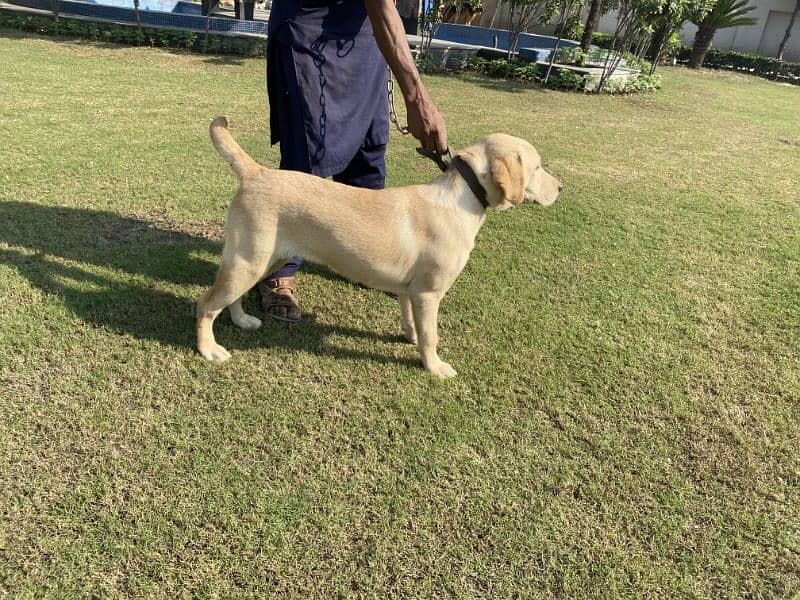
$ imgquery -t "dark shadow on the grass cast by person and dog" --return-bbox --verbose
[0,199,418,366]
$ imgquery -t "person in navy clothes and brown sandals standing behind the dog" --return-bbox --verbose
[258,0,447,322]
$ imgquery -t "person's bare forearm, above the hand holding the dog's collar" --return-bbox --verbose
[364,0,425,102]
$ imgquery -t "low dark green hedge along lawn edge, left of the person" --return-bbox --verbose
[0,10,266,56]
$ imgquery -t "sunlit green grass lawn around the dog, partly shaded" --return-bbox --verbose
[0,31,800,599]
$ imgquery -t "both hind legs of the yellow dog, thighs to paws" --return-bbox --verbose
[197,257,268,362]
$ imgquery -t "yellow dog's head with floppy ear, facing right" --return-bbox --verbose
[458,133,564,210]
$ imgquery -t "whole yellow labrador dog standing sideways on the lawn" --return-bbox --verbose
[197,117,563,378]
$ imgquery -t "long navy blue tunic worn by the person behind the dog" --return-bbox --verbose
[267,0,389,177]
